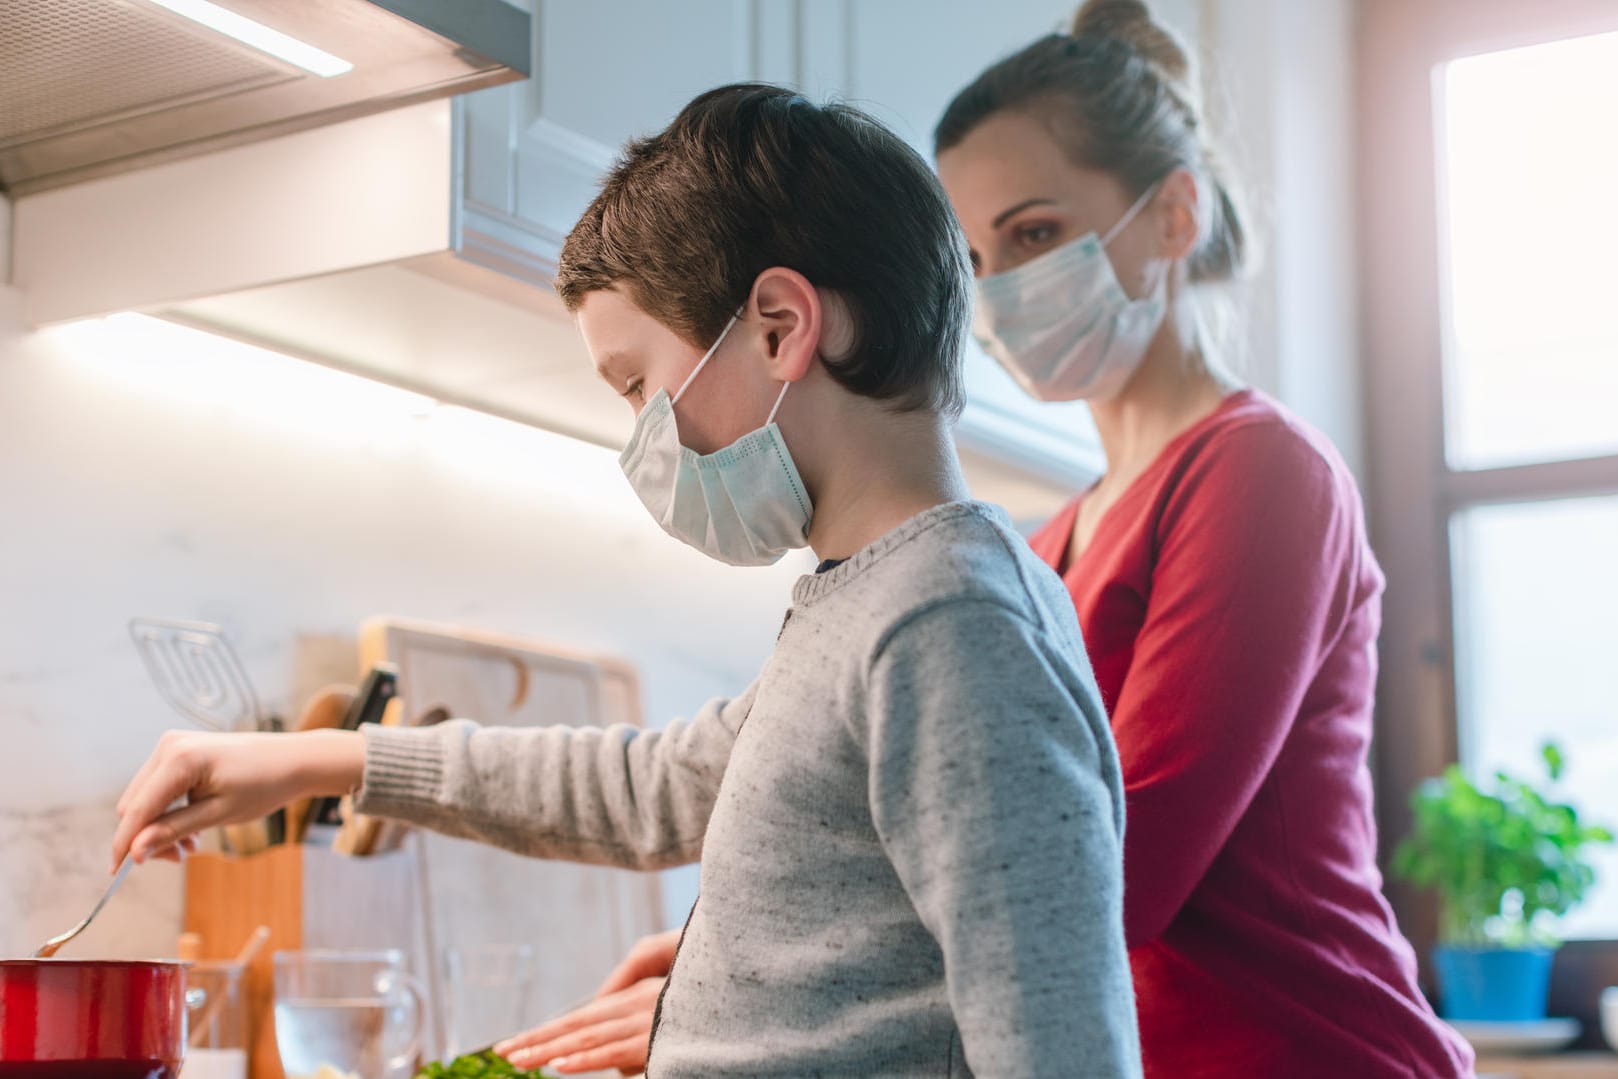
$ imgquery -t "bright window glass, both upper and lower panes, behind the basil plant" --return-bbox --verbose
[1435,25,1618,938]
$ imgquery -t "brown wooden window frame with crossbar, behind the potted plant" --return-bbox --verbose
[1356,0,1618,1047]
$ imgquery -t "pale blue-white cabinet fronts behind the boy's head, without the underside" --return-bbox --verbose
[455,0,1139,487]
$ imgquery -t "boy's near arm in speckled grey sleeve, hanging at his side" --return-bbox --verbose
[867,600,1141,1079]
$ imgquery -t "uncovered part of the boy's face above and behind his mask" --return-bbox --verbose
[578,288,780,453]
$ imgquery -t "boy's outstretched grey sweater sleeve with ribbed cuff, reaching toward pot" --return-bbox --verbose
[354,688,752,869]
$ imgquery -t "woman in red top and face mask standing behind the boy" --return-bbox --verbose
[502,0,1472,1079]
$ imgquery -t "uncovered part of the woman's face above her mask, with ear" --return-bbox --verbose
[938,110,1157,296]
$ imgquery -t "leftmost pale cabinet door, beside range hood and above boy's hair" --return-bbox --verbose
[455,0,846,286]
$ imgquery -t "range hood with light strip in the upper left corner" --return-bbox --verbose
[0,0,531,197]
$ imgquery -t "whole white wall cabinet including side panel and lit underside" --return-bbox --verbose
[13,0,1236,504]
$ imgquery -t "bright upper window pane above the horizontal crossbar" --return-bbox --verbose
[1438,32,1618,469]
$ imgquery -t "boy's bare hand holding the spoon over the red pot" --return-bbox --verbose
[112,731,366,869]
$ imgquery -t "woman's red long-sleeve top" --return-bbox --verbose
[1031,390,1472,1079]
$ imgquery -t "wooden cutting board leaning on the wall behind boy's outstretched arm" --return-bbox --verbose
[359,618,665,1045]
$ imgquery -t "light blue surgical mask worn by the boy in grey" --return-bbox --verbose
[618,312,814,566]
